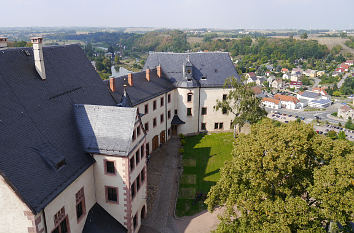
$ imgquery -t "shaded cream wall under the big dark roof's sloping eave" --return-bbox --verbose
[44,166,96,233]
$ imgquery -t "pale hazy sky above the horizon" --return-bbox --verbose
[0,0,354,29]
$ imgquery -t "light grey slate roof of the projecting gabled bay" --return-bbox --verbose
[74,104,137,156]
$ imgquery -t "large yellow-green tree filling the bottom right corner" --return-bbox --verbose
[206,119,354,232]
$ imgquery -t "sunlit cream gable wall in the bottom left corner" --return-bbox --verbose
[0,176,33,233]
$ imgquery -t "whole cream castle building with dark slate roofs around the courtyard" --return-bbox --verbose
[0,37,238,233]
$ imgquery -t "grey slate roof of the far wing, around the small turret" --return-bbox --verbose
[144,52,240,87]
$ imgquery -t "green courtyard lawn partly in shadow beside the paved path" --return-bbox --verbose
[176,133,233,216]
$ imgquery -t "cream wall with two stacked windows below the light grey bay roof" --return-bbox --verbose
[94,154,128,227]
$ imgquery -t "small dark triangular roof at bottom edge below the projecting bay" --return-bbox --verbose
[82,203,128,233]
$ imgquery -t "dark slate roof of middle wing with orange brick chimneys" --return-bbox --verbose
[104,69,176,106]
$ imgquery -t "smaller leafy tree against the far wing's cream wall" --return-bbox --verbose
[215,77,267,135]
